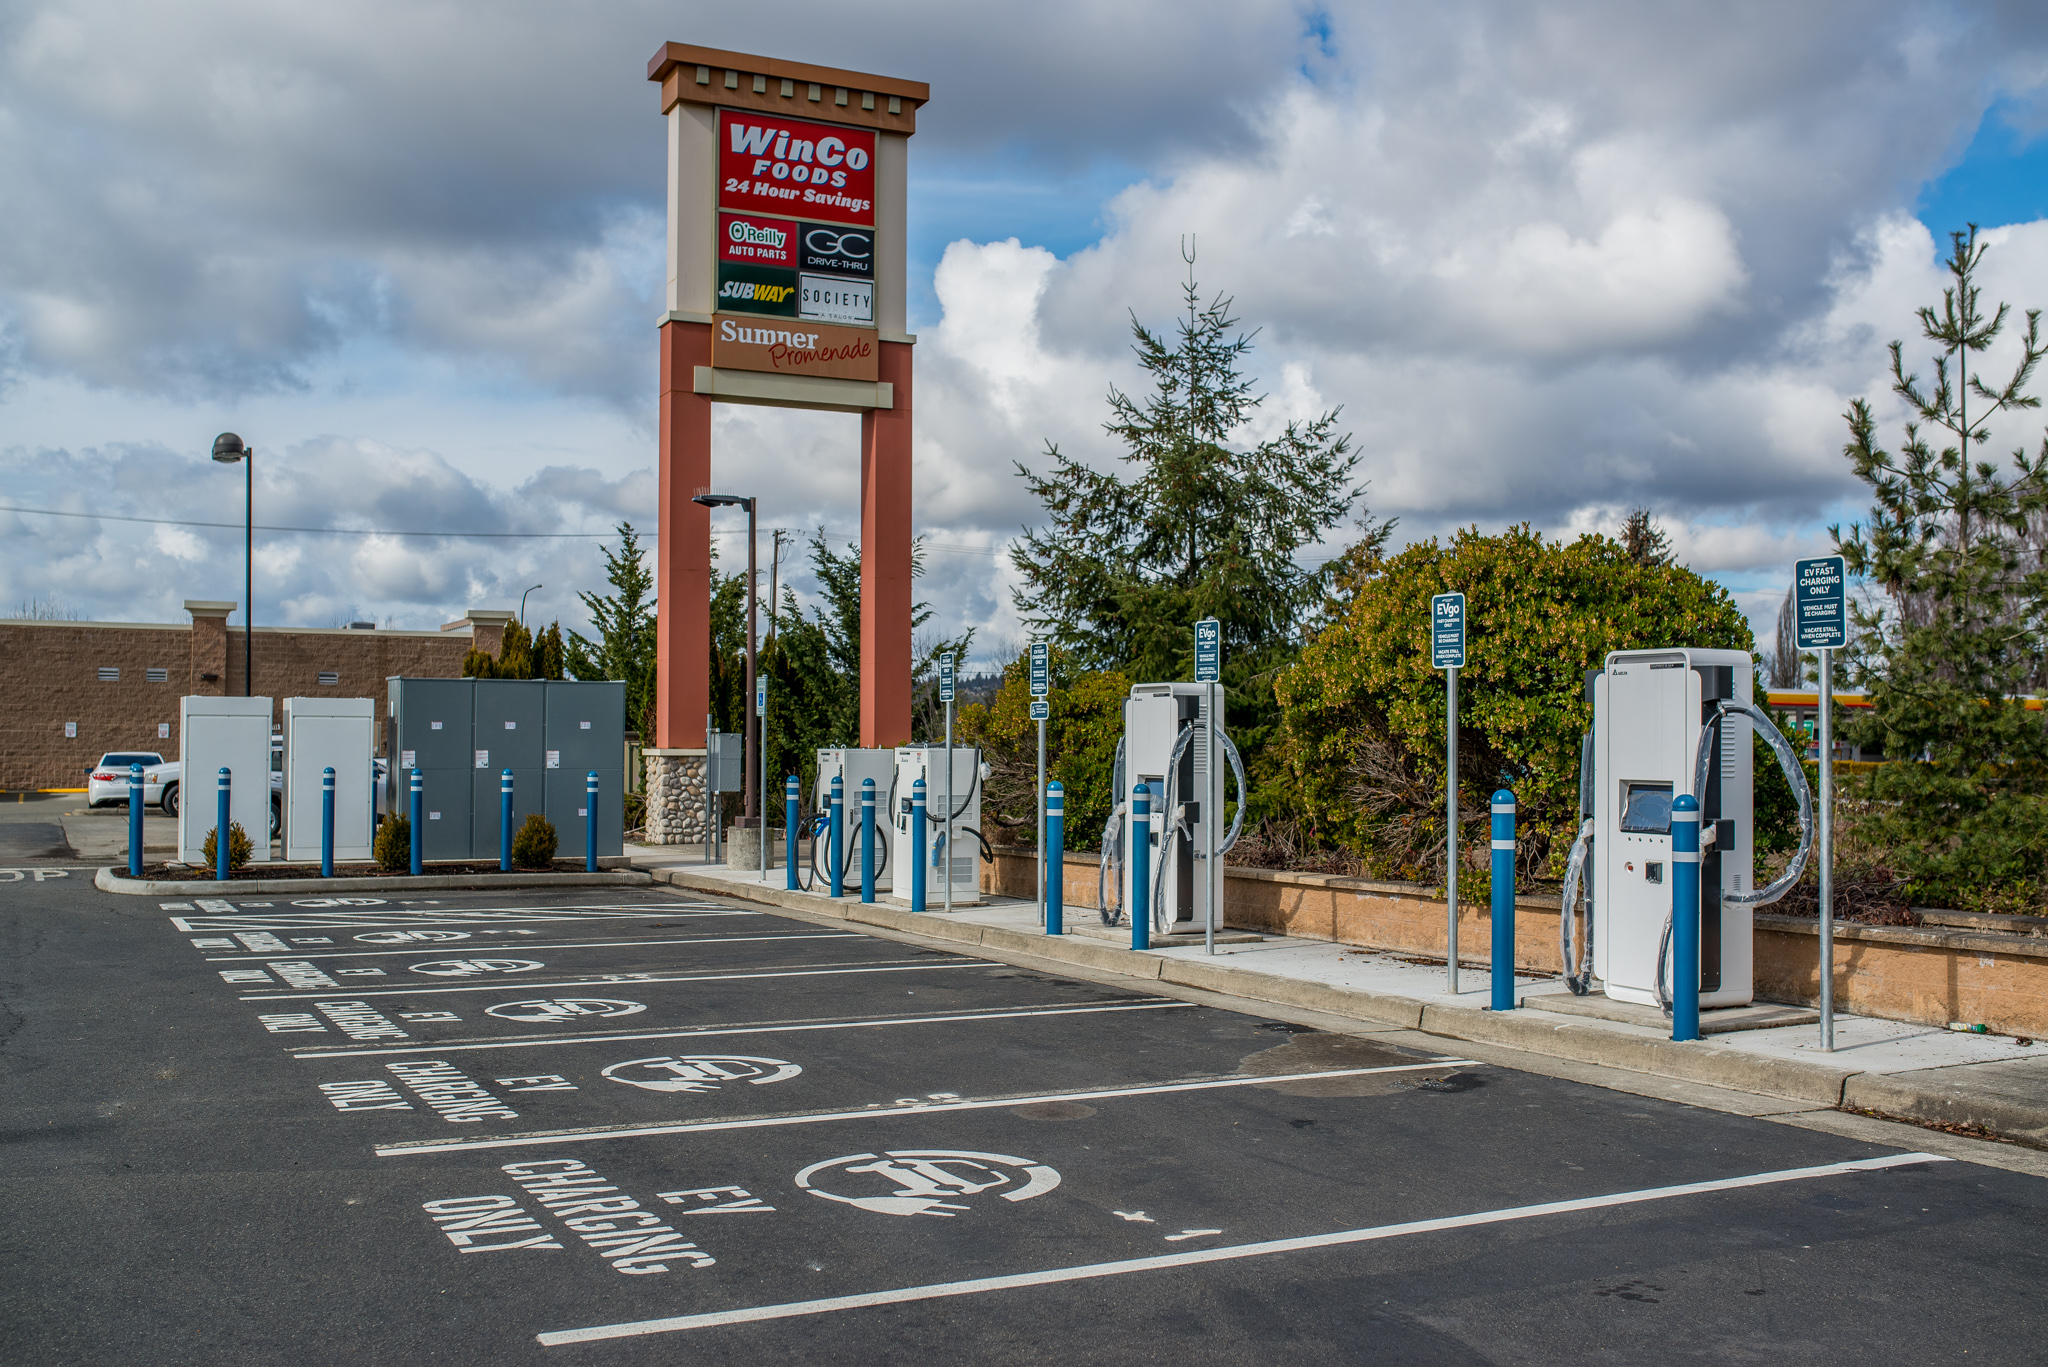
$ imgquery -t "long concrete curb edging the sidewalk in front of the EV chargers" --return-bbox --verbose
[651,869,2048,1148]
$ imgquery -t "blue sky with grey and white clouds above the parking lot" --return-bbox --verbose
[0,0,2048,664]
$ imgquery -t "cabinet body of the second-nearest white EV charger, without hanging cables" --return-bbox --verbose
[1122,682,1225,935]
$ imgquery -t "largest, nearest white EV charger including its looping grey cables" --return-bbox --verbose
[1559,650,1812,1010]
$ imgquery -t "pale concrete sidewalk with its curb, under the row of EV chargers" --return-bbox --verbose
[625,844,2048,1148]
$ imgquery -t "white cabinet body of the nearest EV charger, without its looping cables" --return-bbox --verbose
[1593,650,1755,1006]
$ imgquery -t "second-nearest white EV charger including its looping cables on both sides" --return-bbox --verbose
[1096,682,1245,935]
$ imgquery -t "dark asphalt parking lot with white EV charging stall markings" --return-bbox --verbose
[0,869,2048,1363]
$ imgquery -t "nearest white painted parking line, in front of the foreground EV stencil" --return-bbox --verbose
[535,1154,1950,1349]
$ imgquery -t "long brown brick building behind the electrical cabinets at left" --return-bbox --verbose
[0,600,512,791]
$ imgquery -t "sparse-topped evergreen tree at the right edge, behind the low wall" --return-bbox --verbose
[1829,223,2048,902]
